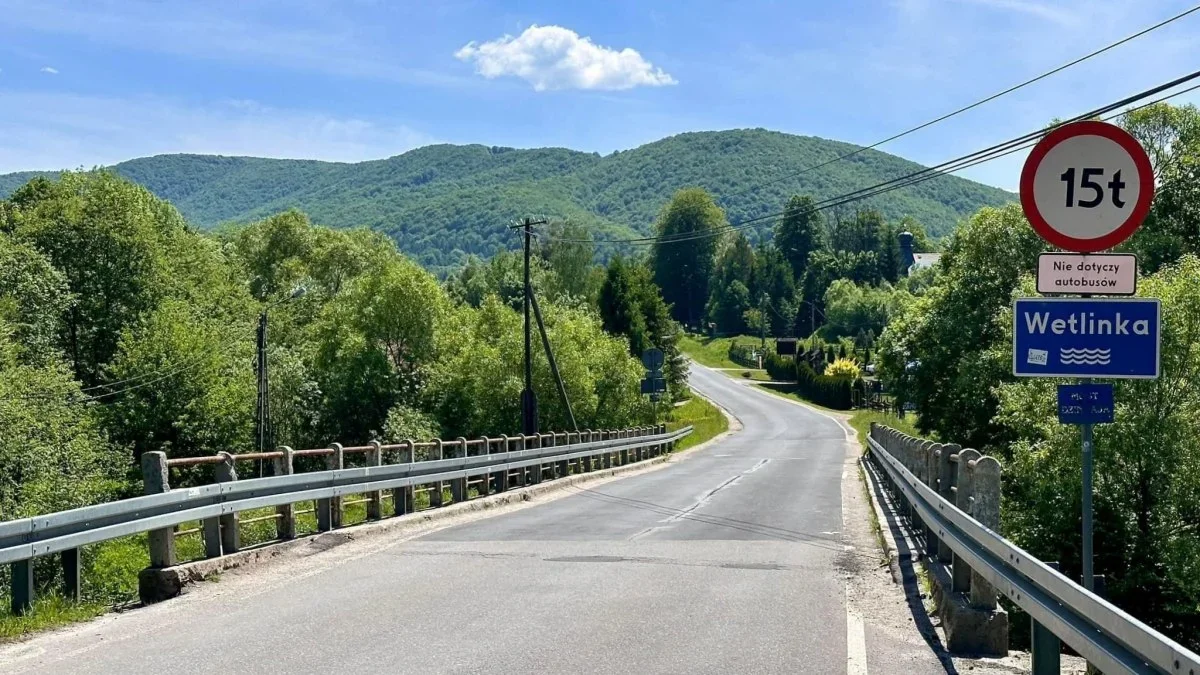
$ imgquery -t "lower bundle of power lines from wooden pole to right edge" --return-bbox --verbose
[535,71,1200,245]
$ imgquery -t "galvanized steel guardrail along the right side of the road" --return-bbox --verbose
[868,424,1200,675]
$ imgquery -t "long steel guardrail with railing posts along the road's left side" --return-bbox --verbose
[0,425,692,614]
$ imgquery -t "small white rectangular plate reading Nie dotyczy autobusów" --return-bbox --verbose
[1038,253,1138,295]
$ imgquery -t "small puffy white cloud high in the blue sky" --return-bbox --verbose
[455,25,676,91]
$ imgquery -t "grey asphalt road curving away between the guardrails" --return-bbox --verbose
[0,369,923,675]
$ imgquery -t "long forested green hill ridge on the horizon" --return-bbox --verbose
[0,130,1014,268]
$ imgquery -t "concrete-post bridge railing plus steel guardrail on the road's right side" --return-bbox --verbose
[868,424,1200,675]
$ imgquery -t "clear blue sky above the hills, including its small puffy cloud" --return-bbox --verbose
[0,0,1200,189]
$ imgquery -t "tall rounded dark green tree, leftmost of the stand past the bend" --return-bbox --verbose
[650,187,728,327]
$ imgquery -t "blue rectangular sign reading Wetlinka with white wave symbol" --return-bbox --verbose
[1013,298,1159,378]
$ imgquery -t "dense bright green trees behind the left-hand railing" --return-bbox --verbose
[0,172,685,520]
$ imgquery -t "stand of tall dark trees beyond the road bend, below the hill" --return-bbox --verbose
[652,183,932,345]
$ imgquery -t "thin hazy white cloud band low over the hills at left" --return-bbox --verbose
[0,90,434,173]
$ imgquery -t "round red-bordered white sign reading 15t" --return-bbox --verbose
[1021,121,1154,253]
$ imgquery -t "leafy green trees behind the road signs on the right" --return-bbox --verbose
[878,104,1200,649]
